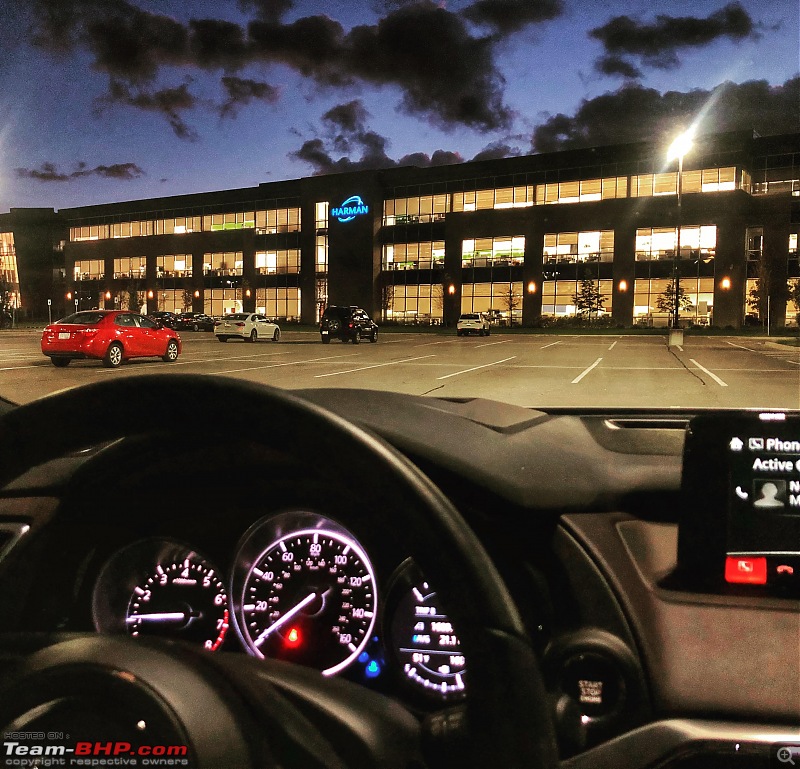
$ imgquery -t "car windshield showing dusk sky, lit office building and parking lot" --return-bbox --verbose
[0,0,800,409]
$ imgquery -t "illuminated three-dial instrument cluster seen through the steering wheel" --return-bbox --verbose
[92,510,466,707]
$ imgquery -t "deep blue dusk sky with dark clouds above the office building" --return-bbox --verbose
[0,0,800,213]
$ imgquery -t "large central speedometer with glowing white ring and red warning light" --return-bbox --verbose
[236,514,377,675]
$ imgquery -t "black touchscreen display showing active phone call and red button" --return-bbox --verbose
[678,412,800,591]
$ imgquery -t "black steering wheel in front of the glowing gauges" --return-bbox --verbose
[0,374,557,769]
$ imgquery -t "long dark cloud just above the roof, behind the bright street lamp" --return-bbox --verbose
[531,77,800,152]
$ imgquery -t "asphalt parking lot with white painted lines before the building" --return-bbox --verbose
[0,327,800,408]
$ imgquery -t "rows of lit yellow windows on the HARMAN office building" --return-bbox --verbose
[50,137,800,325]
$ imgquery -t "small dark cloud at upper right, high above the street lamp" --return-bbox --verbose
[589,3,758,77]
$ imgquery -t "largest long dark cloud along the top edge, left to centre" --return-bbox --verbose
[32,0,512,134]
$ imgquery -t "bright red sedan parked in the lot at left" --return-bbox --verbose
[42,310,181,368]
